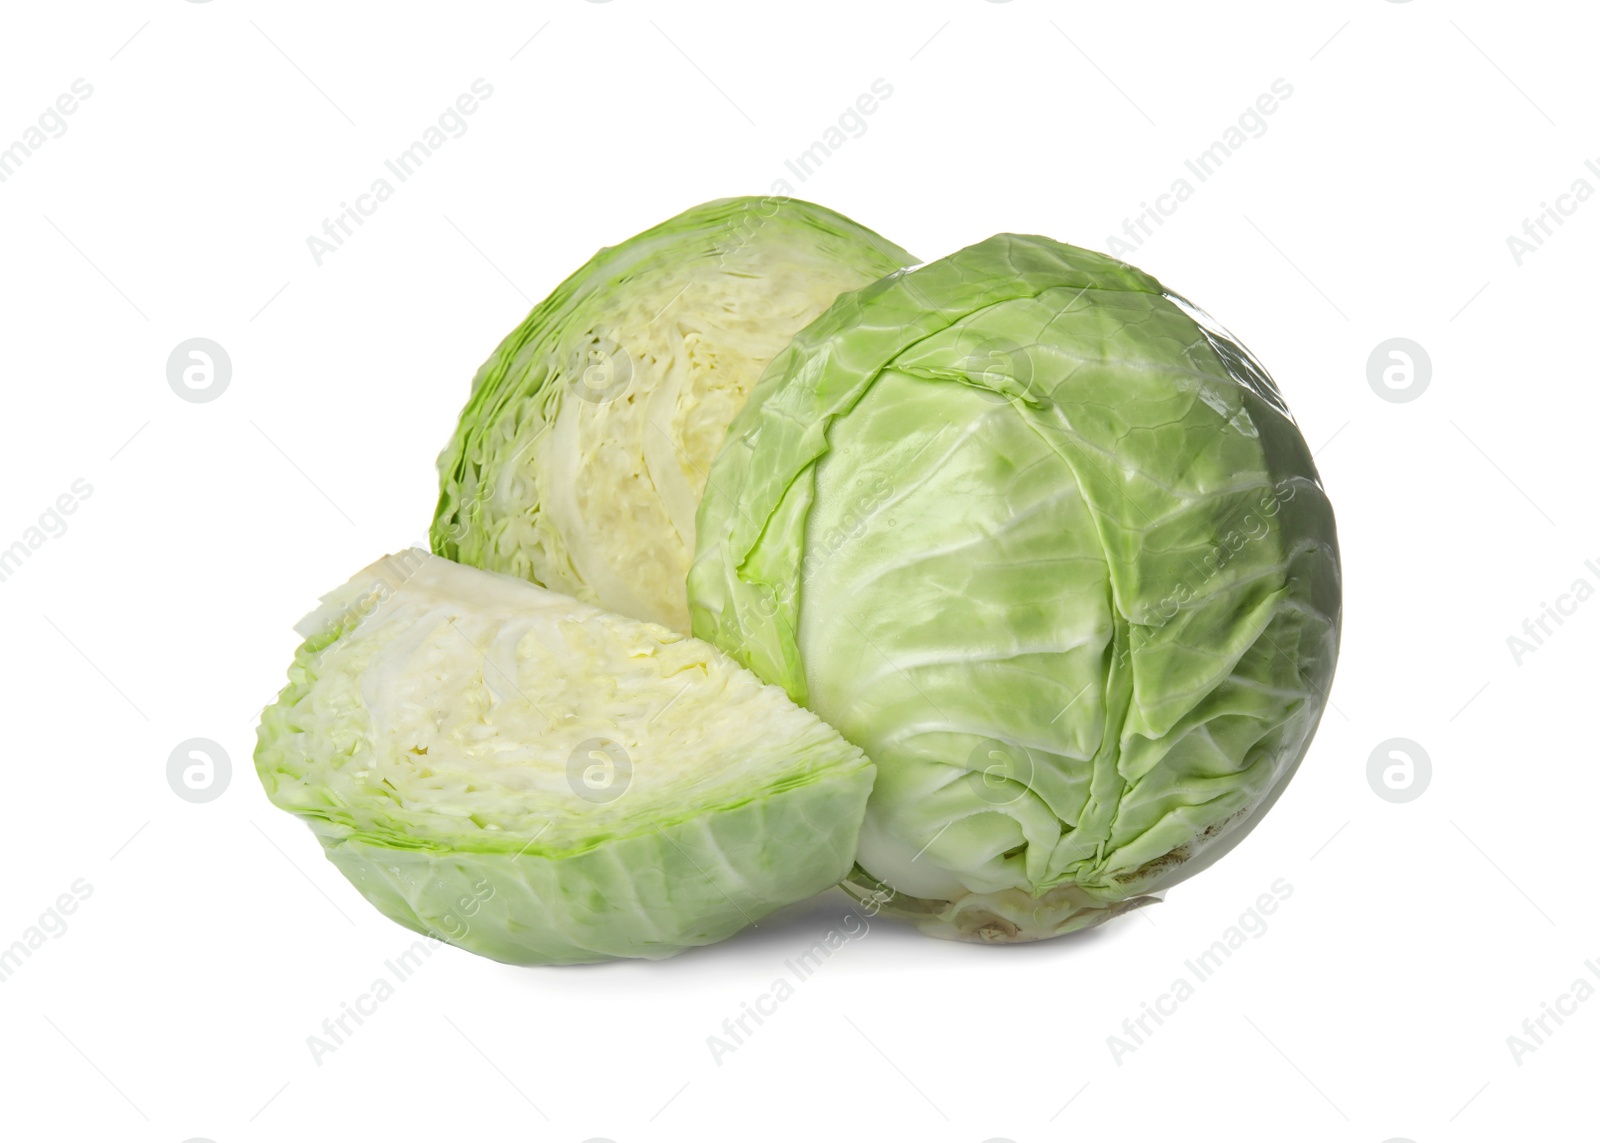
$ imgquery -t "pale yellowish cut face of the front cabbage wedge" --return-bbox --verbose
[274,549,867,853]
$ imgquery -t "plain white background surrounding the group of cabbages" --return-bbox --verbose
[0,0,1600,1143]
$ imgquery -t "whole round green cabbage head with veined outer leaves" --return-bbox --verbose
[690,235,1339,940]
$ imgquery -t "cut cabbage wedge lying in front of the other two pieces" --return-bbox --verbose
[256,549,872,964]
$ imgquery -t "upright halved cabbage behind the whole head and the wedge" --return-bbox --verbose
[432,197,915,632]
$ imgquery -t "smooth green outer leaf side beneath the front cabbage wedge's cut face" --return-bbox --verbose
[304,768,872,965]
